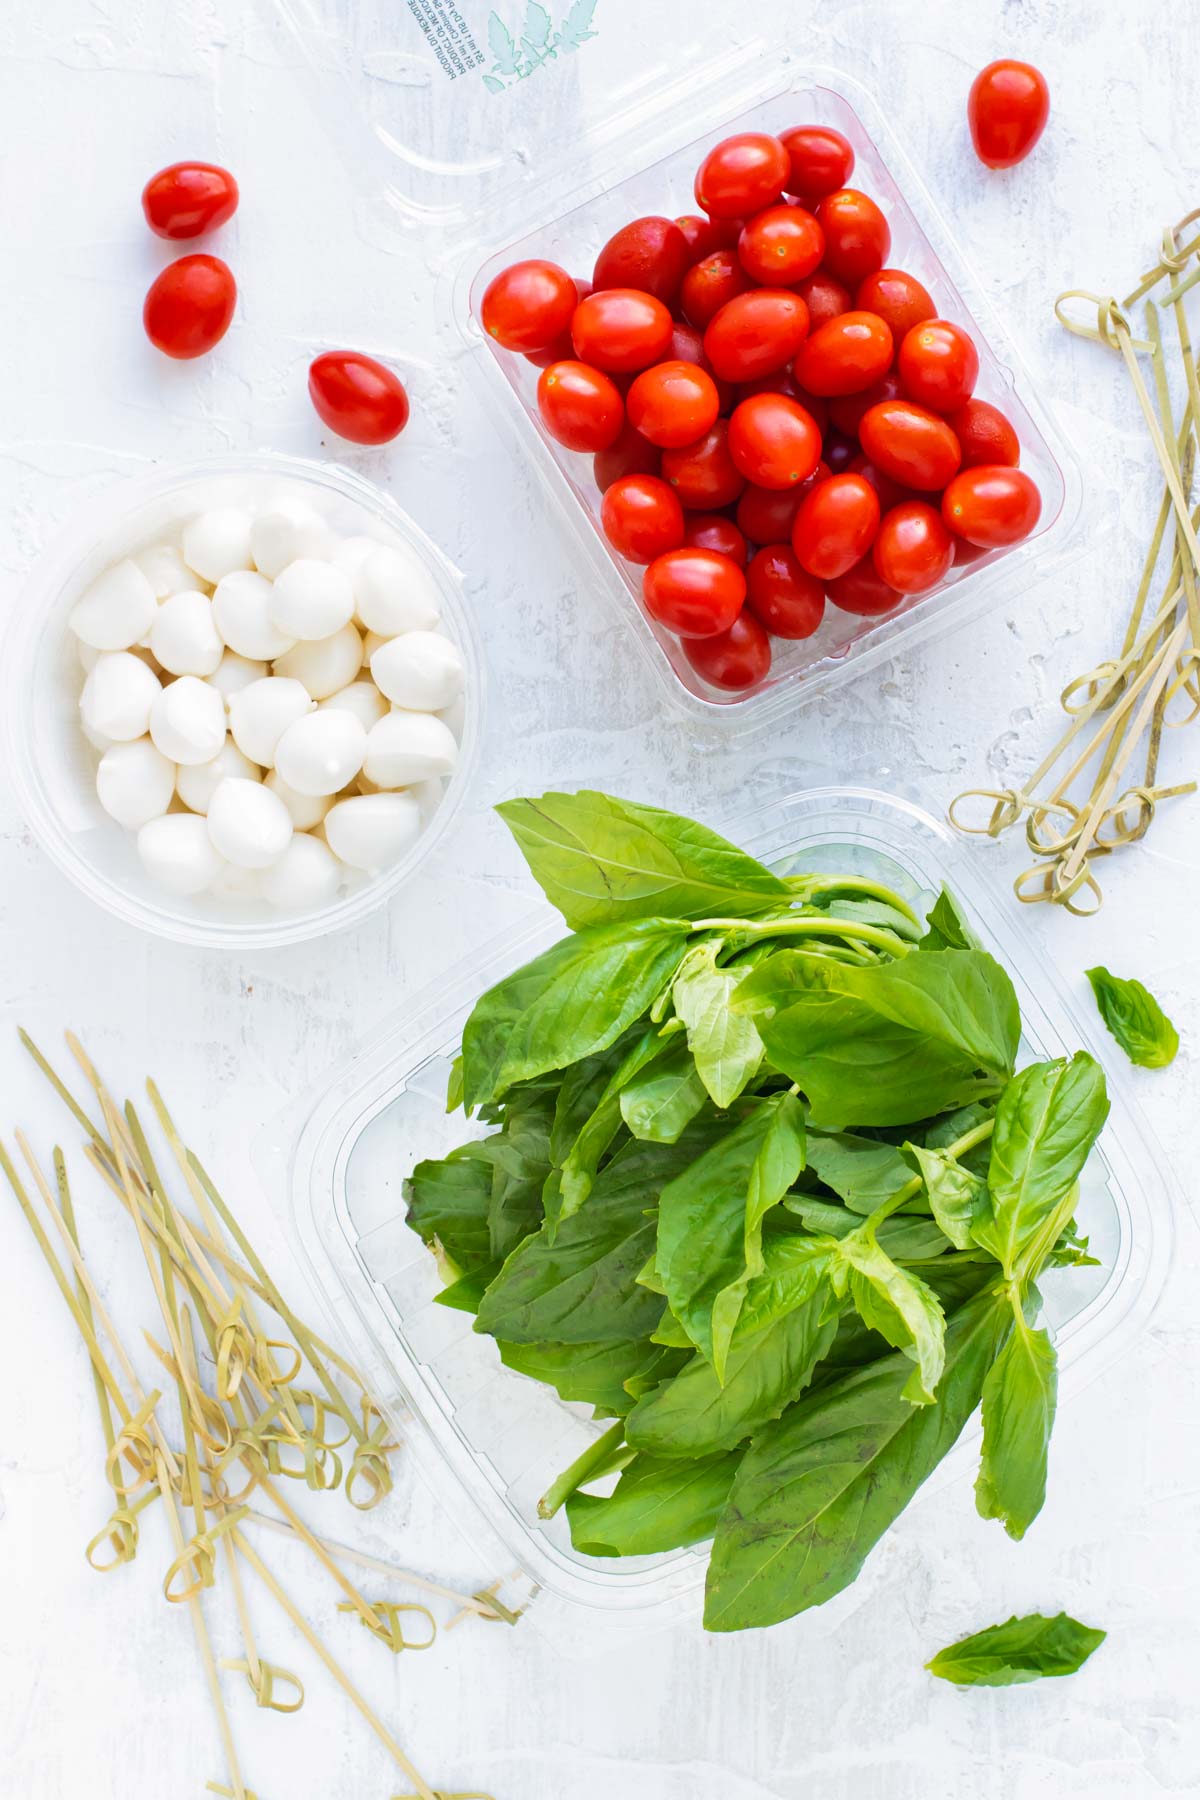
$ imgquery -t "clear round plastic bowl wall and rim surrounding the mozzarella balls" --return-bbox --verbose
[5,454,484,949]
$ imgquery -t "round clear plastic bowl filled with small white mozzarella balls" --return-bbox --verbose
[5,455,482,947]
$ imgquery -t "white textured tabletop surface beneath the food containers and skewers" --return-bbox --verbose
[0,0,1200,1800]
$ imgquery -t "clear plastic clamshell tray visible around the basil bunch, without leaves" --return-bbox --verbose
[266,788,1173,1624]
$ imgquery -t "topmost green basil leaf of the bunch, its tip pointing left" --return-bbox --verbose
[497,788,788,931]
